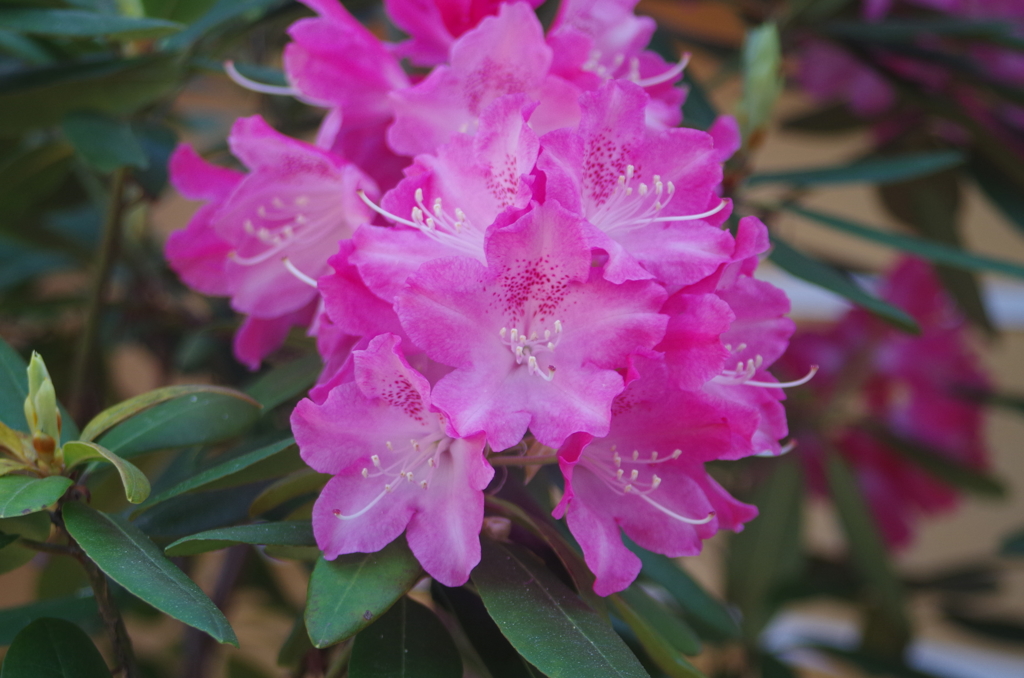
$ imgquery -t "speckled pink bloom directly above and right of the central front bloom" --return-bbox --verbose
[538,81,733,293]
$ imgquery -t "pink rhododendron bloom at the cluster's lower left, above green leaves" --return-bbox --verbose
[292,335,494,586]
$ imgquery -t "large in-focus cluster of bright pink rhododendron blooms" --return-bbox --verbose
[167,0,793,595]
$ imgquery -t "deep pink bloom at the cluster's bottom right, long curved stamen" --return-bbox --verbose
[554,358,758,596]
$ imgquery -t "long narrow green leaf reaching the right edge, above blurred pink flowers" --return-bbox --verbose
[782,203,1024,278]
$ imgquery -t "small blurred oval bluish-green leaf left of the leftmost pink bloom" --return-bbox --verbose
[61,111,148,172]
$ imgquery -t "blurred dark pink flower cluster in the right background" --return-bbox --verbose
[781,259,986,547]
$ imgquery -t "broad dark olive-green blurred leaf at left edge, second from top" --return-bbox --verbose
[0,52,181,136]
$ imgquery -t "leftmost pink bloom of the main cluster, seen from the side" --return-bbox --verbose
[167,116,376,368]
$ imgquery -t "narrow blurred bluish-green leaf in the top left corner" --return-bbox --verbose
[0,8,185,40]
